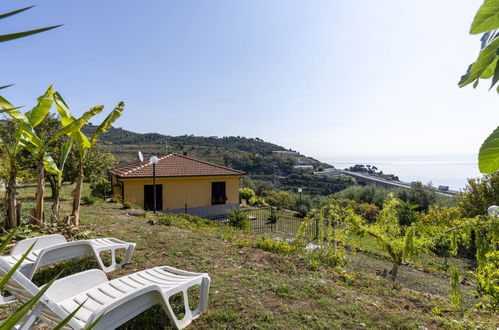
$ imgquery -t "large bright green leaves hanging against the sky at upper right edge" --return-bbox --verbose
[459,0,499,174]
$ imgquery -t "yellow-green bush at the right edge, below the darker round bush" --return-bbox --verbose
[475,251,499,312]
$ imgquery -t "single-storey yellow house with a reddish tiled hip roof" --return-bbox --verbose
[109,153,245,217]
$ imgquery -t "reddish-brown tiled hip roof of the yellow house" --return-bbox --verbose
[109,153,246,178]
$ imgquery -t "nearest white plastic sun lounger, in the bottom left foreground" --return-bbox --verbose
[0,259,210,329]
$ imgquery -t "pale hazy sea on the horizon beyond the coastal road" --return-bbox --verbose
[325,156,482,191]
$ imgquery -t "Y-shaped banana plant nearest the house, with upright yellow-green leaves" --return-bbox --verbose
[54,92,125,226]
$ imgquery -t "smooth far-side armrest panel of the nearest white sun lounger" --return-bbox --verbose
[45,269,108,302]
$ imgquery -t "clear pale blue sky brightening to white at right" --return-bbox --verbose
[0,0,499,160]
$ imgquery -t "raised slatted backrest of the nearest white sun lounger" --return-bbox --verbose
[0,258,74,323]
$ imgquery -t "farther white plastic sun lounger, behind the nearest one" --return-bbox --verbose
[0,234,135,304]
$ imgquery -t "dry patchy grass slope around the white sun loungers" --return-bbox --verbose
[0,186,499,329]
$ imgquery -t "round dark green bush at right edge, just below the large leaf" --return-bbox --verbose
[458,174,499,218]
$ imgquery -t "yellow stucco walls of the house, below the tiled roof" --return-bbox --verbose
[112,176,240,210]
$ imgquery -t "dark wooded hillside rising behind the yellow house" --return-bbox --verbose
[82,125,354,195]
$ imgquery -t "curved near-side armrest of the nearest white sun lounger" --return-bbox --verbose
[85,284,165,328]
